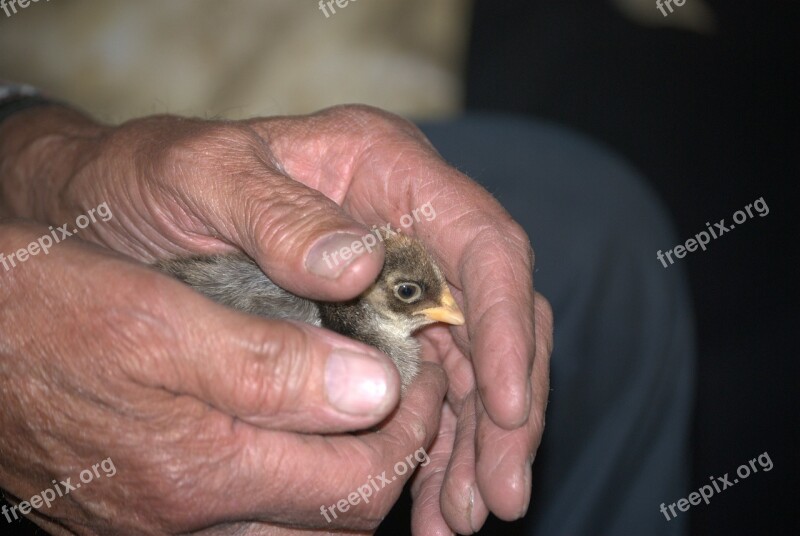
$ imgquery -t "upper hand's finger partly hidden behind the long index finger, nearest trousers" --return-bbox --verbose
[476,294,552,521]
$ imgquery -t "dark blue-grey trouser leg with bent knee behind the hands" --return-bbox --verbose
[423,116,695,536]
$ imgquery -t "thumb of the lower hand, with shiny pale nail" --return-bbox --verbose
[124,268,399,432]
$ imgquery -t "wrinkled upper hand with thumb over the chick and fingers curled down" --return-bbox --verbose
[0,102,552,533]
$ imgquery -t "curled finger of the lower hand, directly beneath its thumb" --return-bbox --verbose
[190,363,447,530]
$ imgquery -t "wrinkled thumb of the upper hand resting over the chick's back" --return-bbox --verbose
[152,123,390,301]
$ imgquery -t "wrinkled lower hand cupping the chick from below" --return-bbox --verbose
[0,224,446,535]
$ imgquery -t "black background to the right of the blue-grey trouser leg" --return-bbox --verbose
[467,0,800,535]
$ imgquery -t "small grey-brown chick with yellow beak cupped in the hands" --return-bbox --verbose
[155,233,464,387]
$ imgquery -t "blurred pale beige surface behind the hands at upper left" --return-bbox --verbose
[0,0,470,122]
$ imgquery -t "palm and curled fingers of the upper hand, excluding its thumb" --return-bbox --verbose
[249,107,553,534]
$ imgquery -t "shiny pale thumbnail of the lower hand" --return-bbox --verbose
[325,350,388,415]
